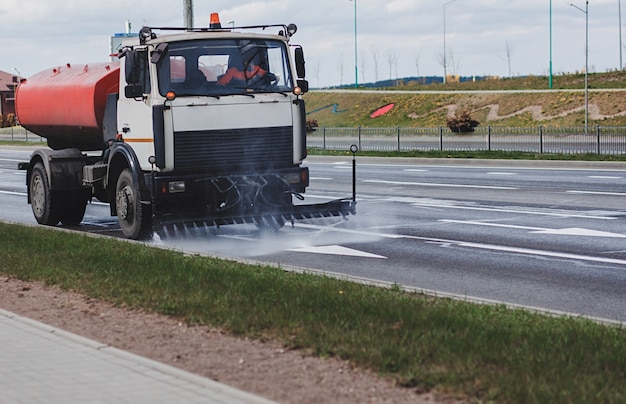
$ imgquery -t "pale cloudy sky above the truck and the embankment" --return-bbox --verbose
[0,0,626,87]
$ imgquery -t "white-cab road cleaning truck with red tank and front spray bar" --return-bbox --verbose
[16,14,356,239]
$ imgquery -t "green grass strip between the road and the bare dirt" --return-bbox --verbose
[0,223,626,403]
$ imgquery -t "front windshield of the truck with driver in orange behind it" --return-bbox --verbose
[157,39,293,96]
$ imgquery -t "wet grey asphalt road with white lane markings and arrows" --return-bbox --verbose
[0,149,626,322]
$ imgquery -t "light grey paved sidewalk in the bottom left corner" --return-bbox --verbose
[0,309,271,404]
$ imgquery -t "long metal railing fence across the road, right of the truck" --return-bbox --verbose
[307,126,626,154]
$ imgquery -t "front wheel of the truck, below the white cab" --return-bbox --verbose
[115,169,152,240]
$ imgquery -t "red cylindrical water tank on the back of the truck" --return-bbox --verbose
[15,62,120,150]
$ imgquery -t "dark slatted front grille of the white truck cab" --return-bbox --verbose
[174,126,293,174]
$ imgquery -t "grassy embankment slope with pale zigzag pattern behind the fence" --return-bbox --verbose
[305,90,626,127]
